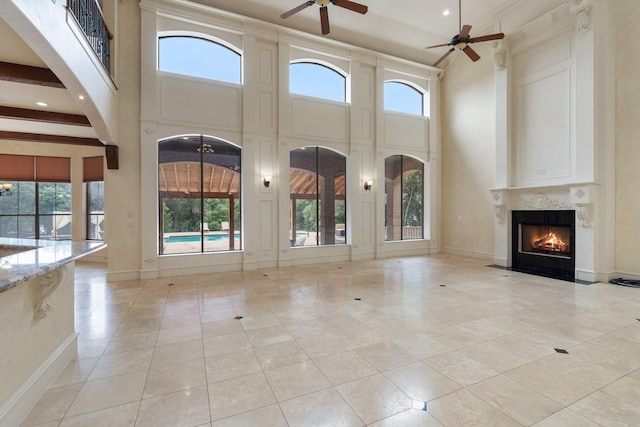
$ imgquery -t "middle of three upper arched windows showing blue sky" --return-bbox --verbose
[289,62,347,102]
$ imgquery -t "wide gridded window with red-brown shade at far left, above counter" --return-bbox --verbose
[0,154,71,240]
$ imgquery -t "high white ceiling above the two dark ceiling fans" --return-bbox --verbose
[191,0,565,65]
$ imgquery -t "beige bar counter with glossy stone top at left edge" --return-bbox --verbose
[0,238,106,426]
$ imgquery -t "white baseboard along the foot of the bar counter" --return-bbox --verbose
[0,331,78,426]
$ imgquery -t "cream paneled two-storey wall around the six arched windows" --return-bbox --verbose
[132,0,438,277]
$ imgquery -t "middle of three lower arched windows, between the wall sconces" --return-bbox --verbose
[289,147,347,246]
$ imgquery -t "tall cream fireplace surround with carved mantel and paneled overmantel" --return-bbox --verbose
[489,0,616,283]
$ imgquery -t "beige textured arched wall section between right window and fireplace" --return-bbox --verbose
[441,43,496,259]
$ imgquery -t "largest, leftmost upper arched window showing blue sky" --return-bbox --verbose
[158,36,242,84]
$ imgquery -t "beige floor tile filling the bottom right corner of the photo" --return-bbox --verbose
[569,391,640,426]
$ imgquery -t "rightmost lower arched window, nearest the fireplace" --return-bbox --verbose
[384,156,424,241]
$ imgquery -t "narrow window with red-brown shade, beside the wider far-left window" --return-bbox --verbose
[82,156,104,240]
